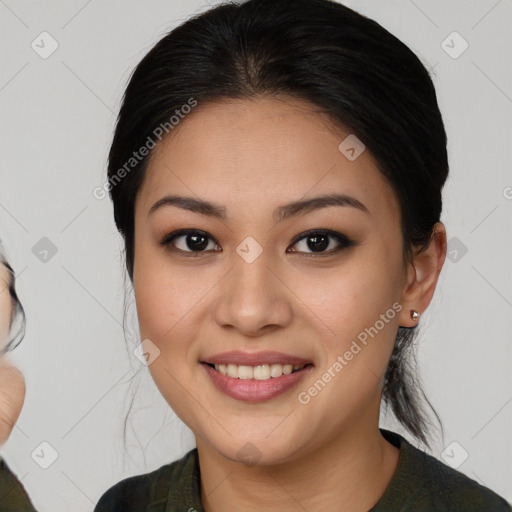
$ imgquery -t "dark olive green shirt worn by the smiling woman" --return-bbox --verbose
[94,429,512,512]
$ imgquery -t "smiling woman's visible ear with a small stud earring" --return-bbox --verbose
[399,222,446,327]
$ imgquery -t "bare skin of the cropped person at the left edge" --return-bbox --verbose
[0,263,25,446]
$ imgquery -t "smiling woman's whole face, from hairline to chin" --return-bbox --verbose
[133,98,407,463]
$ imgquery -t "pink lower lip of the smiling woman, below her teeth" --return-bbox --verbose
[201,363,313,403]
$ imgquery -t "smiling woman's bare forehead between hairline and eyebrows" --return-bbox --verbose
[136,97,398,223]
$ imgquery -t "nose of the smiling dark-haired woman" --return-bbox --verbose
[214,247,293,337]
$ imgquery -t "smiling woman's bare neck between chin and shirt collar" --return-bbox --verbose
[196,406,399,512]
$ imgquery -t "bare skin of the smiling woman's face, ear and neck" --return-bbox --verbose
[133,97,446,512]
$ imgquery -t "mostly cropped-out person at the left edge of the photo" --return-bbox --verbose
[0,246,35,512]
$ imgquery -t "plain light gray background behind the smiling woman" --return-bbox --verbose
[0,0,512,512]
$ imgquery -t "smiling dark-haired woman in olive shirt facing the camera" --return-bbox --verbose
[96,0,510,512]
